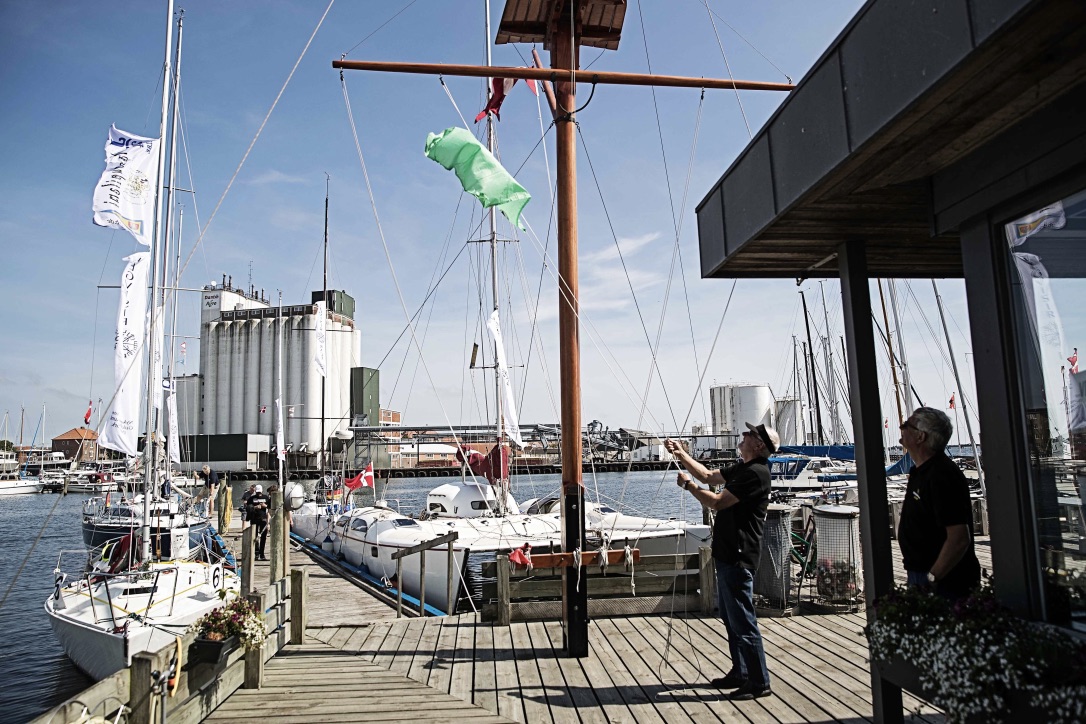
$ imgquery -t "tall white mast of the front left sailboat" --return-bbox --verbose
[140,0,174,561]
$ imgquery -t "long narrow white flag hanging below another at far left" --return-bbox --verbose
[98,252,151,456]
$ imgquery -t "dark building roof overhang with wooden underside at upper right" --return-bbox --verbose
[697,0,1086,278]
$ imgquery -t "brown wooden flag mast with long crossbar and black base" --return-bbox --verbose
[332,0,794,657]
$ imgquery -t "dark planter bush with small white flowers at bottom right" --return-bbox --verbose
[864,584,1086,722]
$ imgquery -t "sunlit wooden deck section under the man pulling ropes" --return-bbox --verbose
[306,614,943,724]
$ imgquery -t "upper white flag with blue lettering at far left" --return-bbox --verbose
[93,126,159,246]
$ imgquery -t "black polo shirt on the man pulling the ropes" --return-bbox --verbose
[712,457,770,571]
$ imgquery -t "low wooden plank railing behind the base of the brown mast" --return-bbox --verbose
[480,548,716,625]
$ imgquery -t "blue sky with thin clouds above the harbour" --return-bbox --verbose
[0,0,986,443]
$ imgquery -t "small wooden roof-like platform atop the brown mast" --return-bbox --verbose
[494,0,626,50]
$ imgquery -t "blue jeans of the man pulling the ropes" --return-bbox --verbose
[714,560,769,687]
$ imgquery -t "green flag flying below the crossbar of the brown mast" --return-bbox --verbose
[426,128,532,229]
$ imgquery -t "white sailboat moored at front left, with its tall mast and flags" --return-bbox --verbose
[43,5,241,679]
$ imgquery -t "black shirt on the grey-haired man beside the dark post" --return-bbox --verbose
[897,453,981,595]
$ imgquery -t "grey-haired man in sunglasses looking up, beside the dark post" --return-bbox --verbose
[897,407,981,598]
